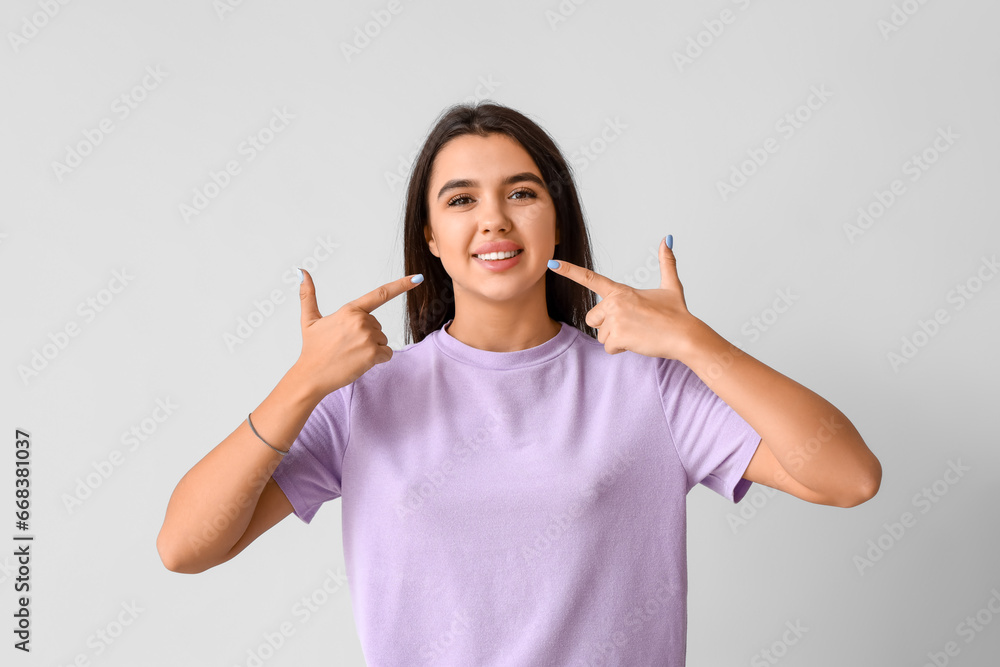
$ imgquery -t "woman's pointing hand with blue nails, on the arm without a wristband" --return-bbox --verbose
[550,235,701,359]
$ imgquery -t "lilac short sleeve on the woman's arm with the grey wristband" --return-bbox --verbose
[271,383,354,523]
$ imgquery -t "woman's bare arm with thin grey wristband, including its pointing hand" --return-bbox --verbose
[156,271,422,574]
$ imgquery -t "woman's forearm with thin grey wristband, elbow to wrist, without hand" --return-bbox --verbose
[156,366,322,572]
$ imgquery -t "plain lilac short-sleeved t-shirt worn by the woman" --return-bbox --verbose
[273,320,760,667]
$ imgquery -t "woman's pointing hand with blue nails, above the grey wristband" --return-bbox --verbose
[295,269,420,398]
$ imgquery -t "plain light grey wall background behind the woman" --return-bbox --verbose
[0,0,1000,667]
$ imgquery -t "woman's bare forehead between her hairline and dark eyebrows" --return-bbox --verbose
[430,134,539,185]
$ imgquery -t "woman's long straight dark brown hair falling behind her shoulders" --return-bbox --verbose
[403,100,597,344]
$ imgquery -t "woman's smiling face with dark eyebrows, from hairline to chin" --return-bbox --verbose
[424,134,559,300]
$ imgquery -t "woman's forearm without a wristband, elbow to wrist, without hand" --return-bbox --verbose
[680,318,882,498]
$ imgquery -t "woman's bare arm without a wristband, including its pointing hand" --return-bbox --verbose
[553,237,882,507]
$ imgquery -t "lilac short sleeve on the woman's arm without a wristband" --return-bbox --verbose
[656,358,760,503]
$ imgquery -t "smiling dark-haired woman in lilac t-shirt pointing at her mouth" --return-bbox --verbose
[157,104,881,667]
